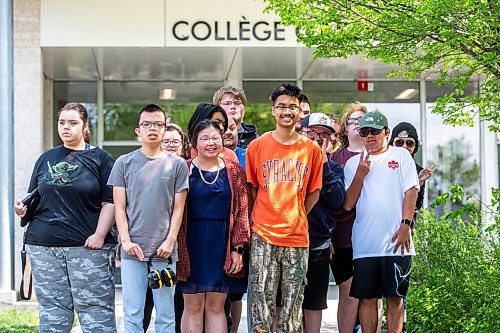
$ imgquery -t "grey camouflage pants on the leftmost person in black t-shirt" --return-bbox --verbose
[27,245,116,333]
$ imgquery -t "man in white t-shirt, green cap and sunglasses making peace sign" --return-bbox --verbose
[343,111,419,333]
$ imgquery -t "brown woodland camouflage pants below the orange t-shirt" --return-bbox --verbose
[250,234,309,333]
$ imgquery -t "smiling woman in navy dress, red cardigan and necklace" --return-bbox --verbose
[177,120,250,333]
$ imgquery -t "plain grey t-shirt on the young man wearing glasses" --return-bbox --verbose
[108,149,189,261]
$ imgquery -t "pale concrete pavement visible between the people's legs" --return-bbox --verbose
[71,286,338,333]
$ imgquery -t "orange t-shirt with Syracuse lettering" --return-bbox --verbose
[246,133,323,247]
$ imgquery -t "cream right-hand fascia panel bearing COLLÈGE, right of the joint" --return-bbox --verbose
[165,0,297,47]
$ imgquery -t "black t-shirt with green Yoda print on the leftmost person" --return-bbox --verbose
[26,145,116,247]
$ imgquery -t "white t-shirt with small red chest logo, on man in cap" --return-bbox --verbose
[344,146,420,259]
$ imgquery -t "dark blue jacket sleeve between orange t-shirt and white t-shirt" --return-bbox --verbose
[307,158,345,249]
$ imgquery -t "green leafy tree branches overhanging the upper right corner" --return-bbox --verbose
[267,0,500,131]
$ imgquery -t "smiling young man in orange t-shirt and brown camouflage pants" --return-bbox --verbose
[246,84,323,333]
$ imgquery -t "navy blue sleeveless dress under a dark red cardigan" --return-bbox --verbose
[177,165,238,294]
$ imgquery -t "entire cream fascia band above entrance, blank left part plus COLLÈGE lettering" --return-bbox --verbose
[40,0,297,47]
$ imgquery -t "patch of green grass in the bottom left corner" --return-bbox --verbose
[0,310,38,333]
